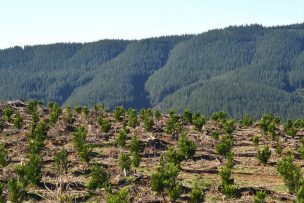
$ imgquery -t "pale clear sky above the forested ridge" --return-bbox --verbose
[0,0,304,48]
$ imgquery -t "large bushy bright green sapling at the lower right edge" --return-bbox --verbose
[277,156,303,193]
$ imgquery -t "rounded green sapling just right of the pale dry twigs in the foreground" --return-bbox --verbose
[87,164,110,190]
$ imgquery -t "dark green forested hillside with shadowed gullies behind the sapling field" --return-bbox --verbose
[0,24,304,119]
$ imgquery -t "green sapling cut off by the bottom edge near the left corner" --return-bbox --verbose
[8,178,26,203]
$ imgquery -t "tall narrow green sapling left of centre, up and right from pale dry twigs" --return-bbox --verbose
[73,126,92,163]
